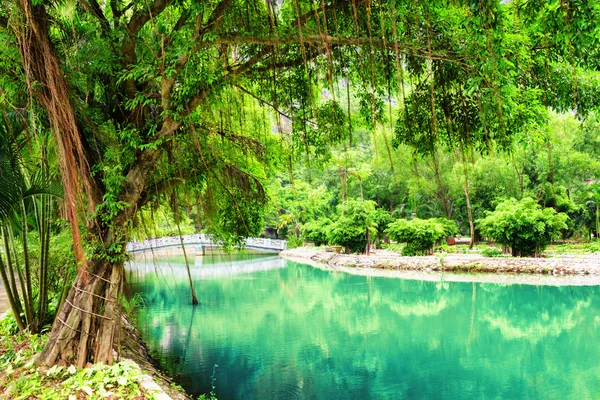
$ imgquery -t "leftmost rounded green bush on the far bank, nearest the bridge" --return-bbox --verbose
[328,199,377,253]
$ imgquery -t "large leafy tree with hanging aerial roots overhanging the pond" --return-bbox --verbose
[0,0,592,366]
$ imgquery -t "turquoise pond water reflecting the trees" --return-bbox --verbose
[128,256,600,400]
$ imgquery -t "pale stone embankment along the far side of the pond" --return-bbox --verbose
[280,247,600,284]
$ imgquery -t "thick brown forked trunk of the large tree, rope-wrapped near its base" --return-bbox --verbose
[13,0,185,367]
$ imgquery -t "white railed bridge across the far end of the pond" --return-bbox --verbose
[127,234,287,253]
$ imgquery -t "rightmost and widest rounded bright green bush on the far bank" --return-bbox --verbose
[477,197,568,257]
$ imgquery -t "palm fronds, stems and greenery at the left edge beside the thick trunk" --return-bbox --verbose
[0,119,65,332]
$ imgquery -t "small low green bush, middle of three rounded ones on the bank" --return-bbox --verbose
[387,218,448,256]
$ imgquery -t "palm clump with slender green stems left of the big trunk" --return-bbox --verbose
[0,123,62,331]
